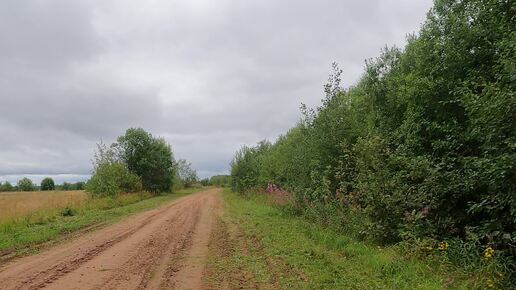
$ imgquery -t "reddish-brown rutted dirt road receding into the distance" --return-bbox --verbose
[0,189,221,289]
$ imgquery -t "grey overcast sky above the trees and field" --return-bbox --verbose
[0,0,431,182]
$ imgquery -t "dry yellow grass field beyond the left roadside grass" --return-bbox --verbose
[0,190,87,223]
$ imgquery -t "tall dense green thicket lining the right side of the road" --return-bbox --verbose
[231,0,516,284]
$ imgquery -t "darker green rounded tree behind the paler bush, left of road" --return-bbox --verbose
[116,128,176,193]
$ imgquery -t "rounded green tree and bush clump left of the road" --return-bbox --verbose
[86,128,177,195]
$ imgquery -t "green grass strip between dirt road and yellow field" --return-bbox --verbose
[0,188,202,255]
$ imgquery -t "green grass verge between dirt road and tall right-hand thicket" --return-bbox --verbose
[206,190,484,289]
